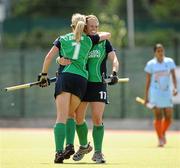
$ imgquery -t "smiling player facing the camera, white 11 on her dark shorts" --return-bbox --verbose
[57,15,119,163]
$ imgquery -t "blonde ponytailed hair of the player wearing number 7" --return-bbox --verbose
[71,13,86,42]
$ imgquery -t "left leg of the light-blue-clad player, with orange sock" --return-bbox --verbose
[153,108,164,147]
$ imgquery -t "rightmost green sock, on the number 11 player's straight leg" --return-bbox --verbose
[92,125,104,152]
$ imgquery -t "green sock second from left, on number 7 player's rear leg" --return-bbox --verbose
[66,118,76,145]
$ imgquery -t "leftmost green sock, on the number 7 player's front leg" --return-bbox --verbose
[54,123,66,152]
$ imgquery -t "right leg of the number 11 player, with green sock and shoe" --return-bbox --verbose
[91,102,106,163]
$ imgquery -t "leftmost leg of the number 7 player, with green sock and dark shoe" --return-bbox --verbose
[54,92,70,163]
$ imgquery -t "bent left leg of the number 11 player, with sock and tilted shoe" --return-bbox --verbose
[73,102,92,161]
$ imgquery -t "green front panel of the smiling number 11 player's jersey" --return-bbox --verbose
[87,41,106,82]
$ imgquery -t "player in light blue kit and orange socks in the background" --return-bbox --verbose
[145,44,177,147]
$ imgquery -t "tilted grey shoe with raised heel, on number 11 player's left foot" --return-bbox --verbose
[73,143,93,161]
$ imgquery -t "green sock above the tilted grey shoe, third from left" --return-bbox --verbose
[76,122,88,146]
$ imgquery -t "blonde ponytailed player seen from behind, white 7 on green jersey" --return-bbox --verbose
[38,14,110,163]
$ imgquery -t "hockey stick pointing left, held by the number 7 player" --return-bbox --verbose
[4,77,56,92]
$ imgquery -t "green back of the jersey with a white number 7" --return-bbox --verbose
[59,33,92,79]
